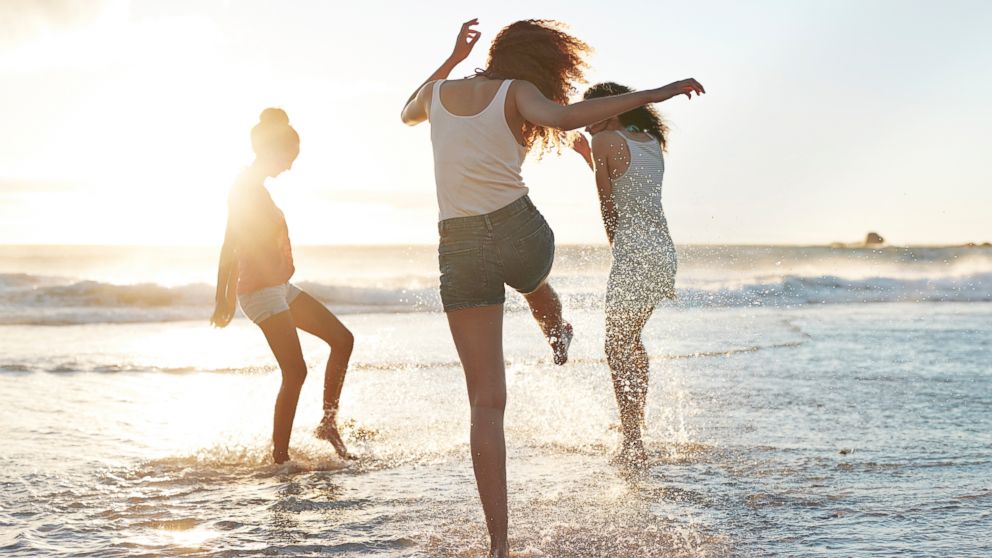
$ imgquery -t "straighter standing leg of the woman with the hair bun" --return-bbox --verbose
[259,312,307,463]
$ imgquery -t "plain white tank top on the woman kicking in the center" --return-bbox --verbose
[429,80,527,221]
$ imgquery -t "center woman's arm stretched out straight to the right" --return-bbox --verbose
[514,78,706,131]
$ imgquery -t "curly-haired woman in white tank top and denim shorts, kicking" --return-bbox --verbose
[402,19,703,557]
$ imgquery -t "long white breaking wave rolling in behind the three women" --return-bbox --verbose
[0,271,992,325]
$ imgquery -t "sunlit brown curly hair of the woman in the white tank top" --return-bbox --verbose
[476,19,591,154]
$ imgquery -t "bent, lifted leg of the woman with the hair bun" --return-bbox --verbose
[289,293,355,457]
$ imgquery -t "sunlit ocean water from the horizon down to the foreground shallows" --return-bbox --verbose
[0,246,992,558]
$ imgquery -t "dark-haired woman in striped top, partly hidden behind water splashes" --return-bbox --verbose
[573,83,678,466]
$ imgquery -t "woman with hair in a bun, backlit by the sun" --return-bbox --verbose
[210,108,354,463]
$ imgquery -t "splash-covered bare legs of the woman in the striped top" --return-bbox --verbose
[606,307,653,465]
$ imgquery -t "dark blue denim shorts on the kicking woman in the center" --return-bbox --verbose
[437,196,555,312]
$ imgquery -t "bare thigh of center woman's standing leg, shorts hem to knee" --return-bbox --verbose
[447,304,506,404]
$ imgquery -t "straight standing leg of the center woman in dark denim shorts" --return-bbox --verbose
[448,304,509,558]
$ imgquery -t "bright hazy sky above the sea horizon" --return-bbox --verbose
[0,0,992,245]
